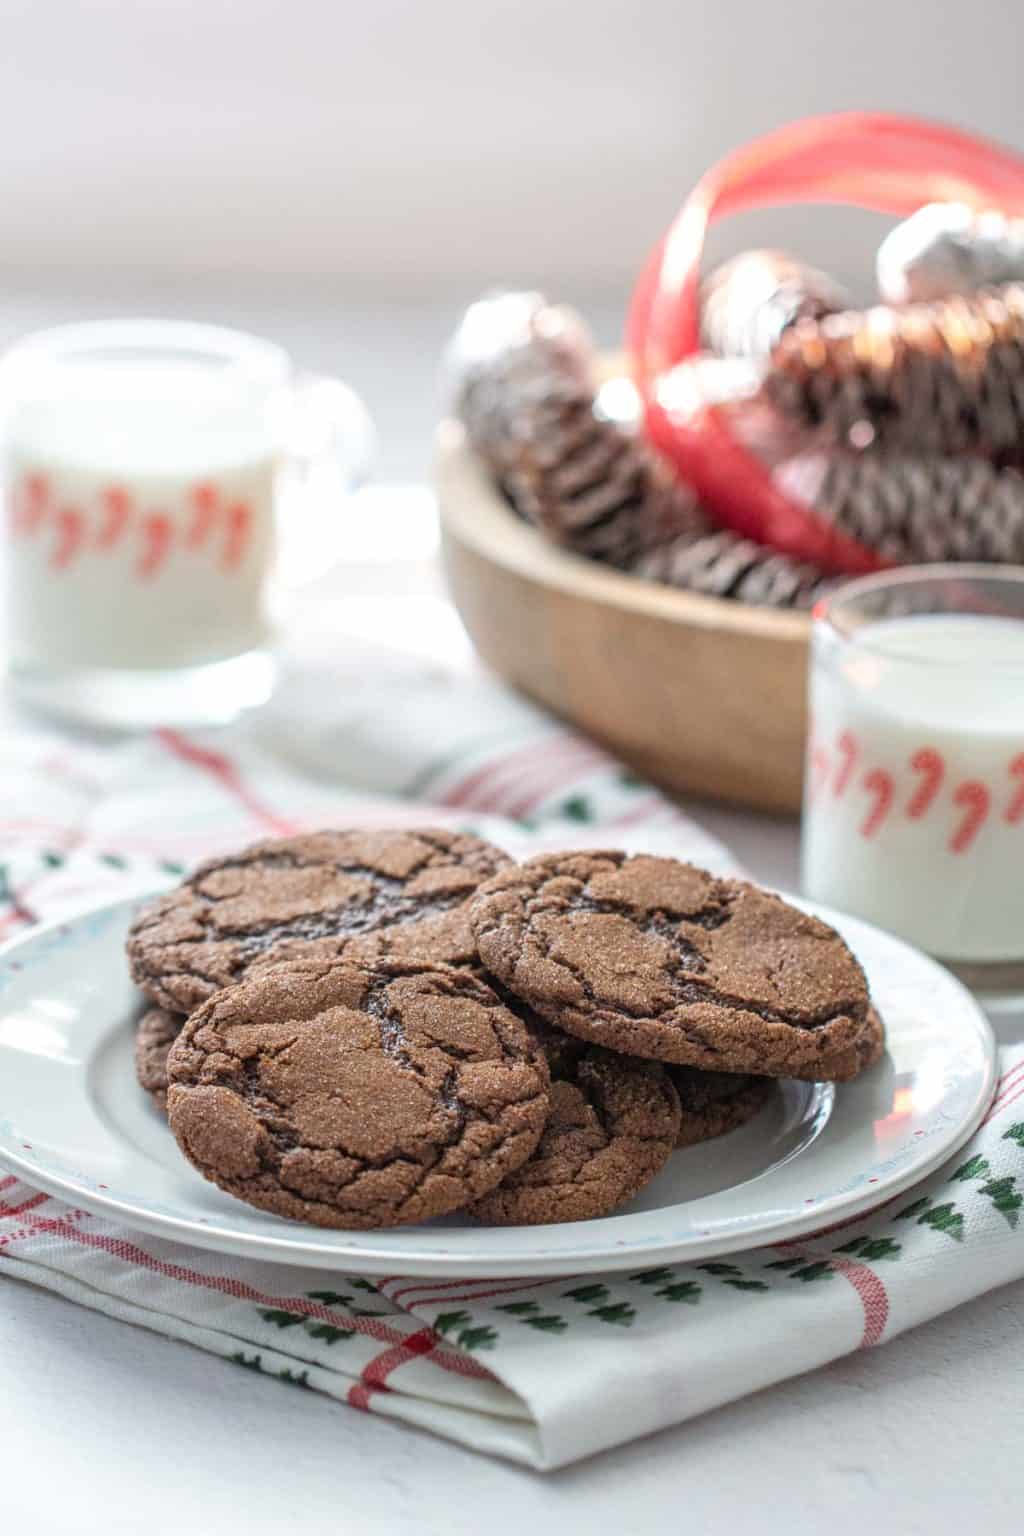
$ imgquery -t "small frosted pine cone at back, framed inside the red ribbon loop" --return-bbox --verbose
[700,250,849,362]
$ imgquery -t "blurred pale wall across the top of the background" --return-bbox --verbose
[0,0,1024,290]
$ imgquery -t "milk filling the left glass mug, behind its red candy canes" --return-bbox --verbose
[3,353,275,670]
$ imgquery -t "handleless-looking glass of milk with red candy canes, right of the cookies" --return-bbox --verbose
[803,565,1024,991]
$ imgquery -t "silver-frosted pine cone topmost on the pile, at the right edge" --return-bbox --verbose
[875,203,1024,304]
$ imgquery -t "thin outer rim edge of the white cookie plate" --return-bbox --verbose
[0,883,999,1279]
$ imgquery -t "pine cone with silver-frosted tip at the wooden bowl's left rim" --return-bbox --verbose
[457,295,706,565]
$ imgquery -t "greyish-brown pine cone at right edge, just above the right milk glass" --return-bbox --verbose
[775,453,1024,564]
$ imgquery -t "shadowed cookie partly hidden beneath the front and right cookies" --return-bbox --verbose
[473,1031,680,1226]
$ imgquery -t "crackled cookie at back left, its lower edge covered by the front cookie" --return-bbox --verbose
[127,828,508,1014]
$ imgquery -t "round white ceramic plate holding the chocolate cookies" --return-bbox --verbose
[0,900,996,1276]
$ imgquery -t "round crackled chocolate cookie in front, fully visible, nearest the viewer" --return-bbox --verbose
[167,962,548,1229]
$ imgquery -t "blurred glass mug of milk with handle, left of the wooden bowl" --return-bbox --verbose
[0,319,368,728]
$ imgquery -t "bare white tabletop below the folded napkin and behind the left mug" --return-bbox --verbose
[0,284,1024,1536]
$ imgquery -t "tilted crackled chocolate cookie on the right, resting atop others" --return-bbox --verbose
[470,851,878,1081]
